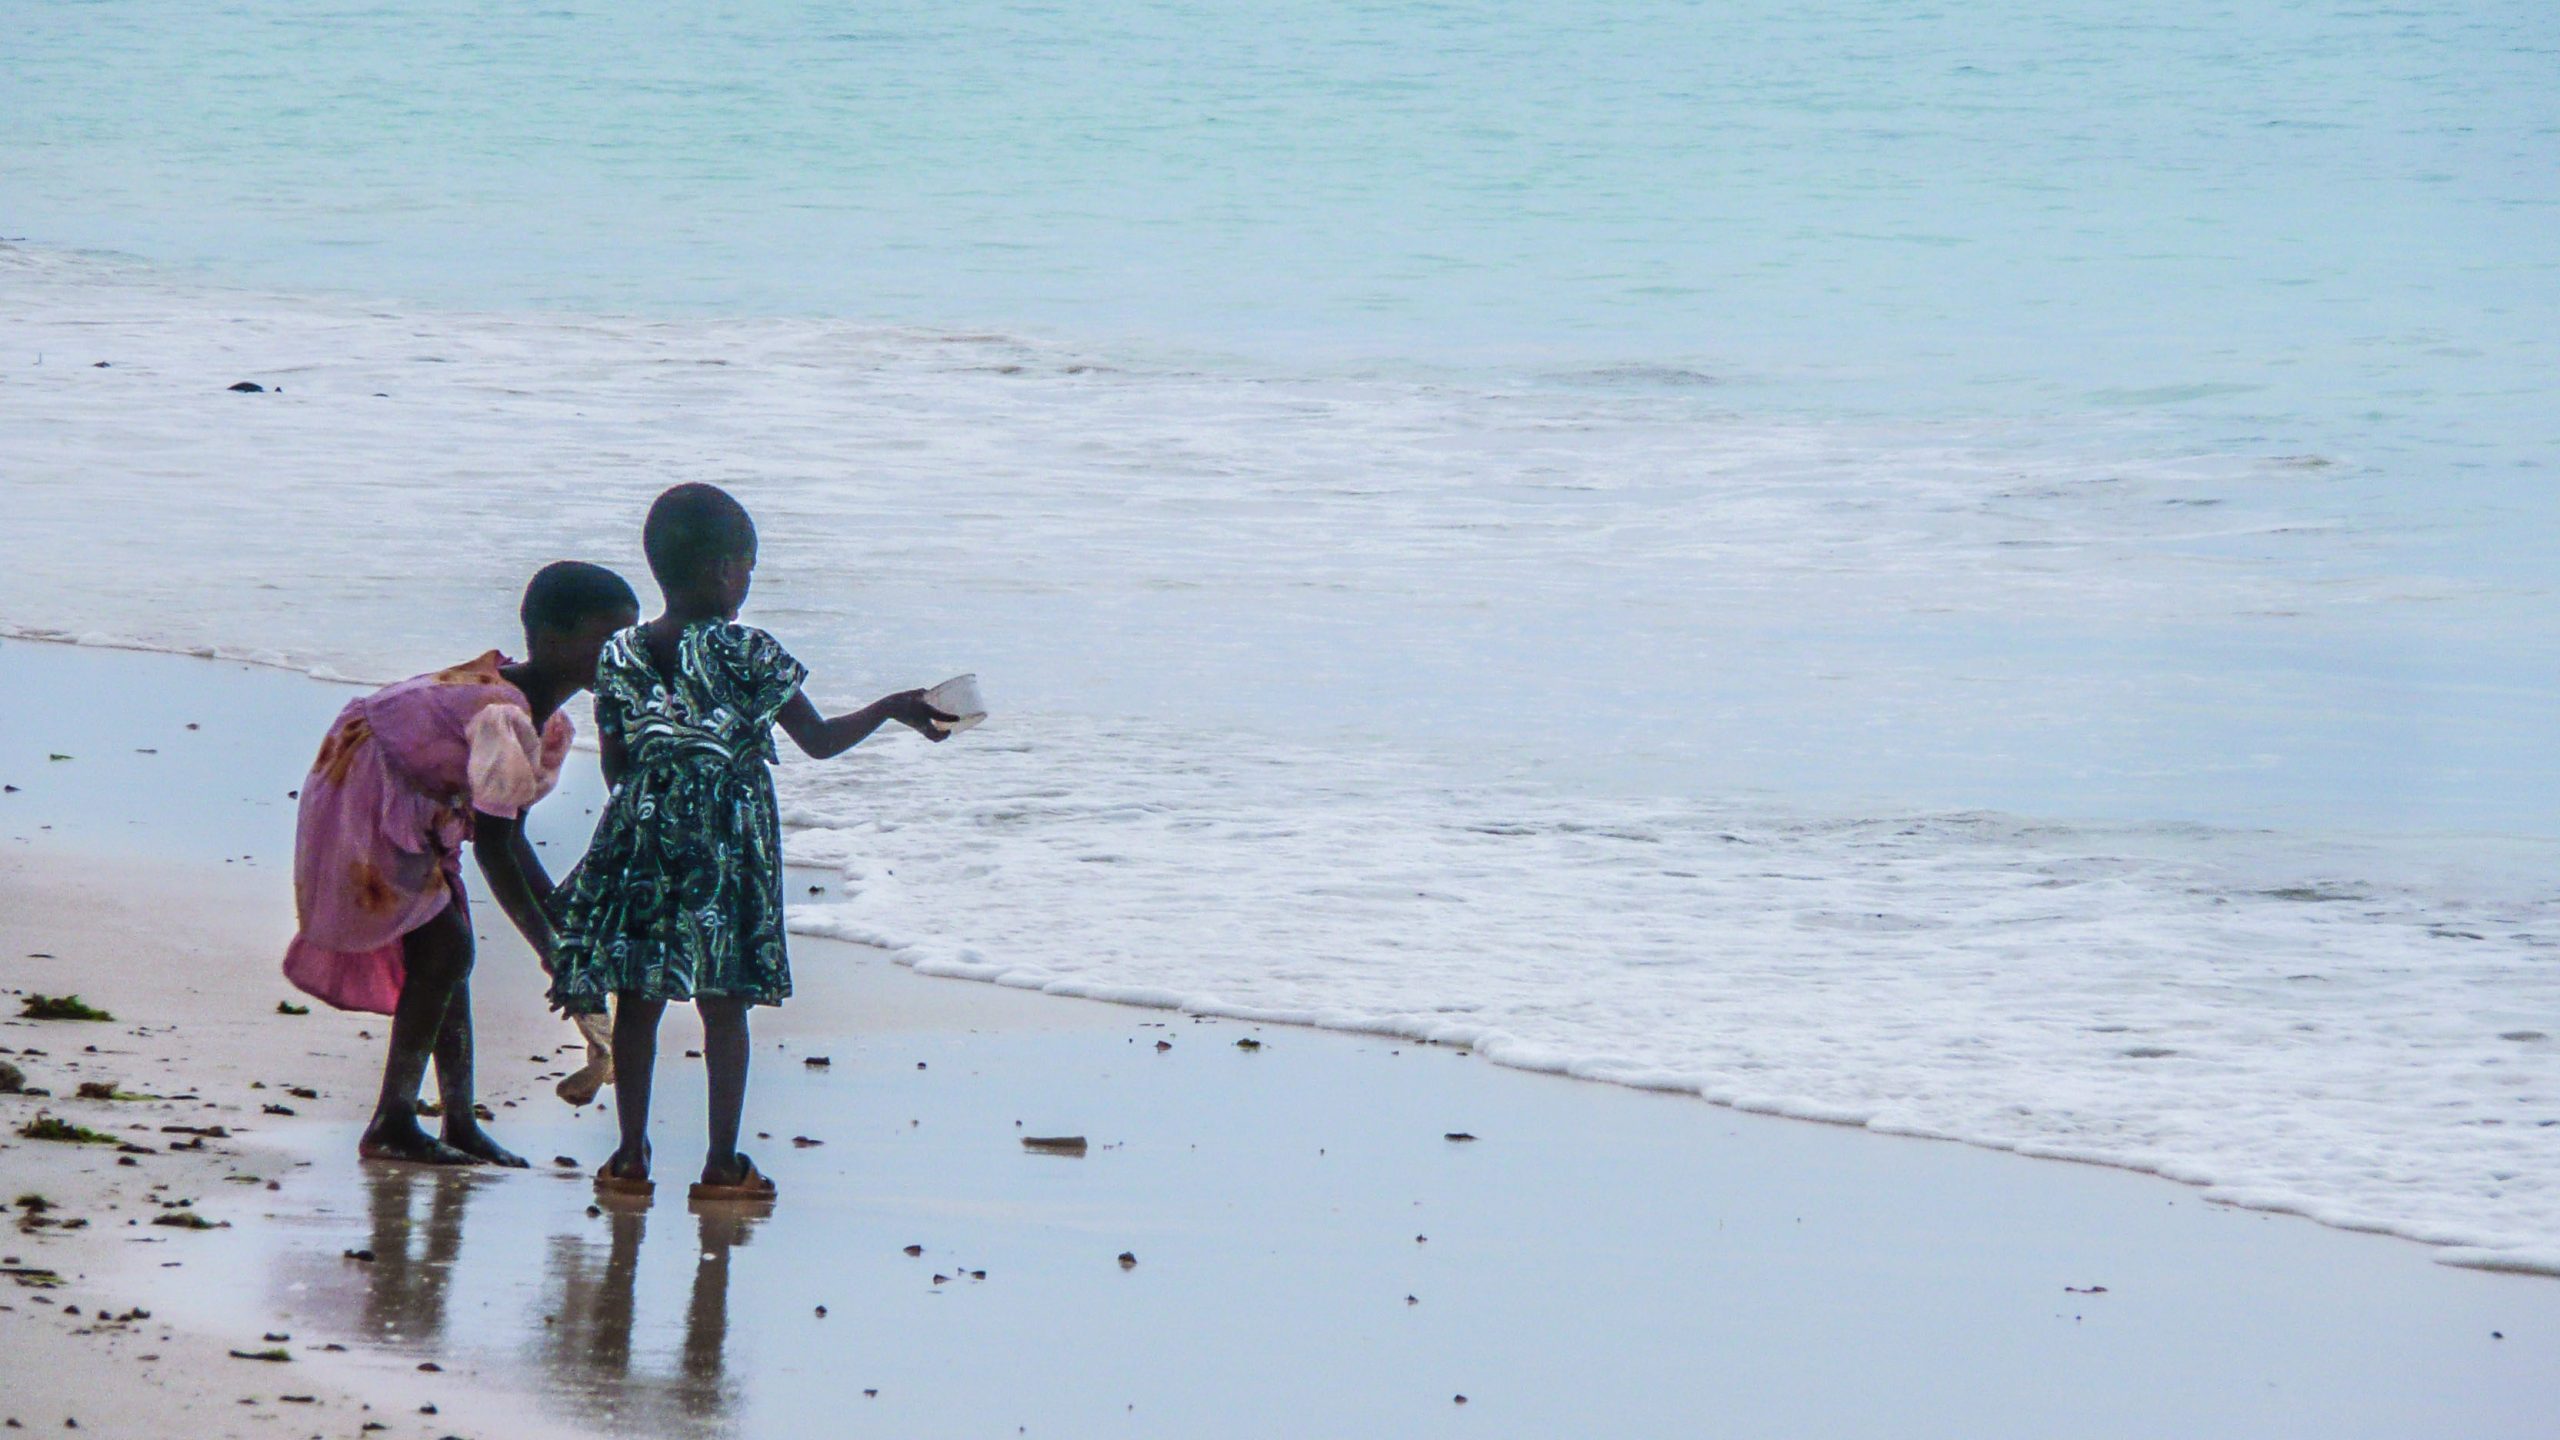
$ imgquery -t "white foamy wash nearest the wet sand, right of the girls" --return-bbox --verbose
[786,717,2560,1273]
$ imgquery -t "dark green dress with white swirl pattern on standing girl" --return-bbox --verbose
[550,620,809,1015]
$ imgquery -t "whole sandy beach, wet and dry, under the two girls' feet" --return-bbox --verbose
[0,643,2560,1437]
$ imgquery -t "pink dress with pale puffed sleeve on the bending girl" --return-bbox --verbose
[284,651,573,1015]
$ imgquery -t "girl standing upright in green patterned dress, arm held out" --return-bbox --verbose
[550,484,955,1199]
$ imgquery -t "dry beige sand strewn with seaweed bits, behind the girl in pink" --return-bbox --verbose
[0,848,593,1440]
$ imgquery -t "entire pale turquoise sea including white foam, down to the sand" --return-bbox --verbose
[0,0,2560,1276]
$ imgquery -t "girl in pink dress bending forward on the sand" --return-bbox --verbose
[284,561,640,1166]
